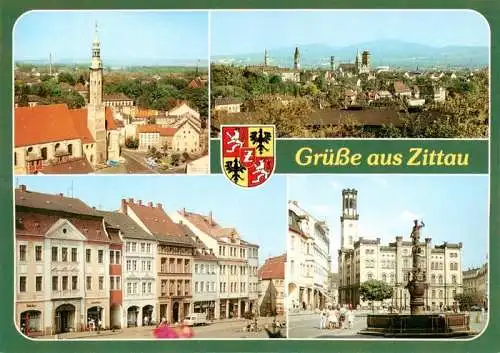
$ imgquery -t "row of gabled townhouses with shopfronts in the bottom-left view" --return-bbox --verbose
[15,185,258,335]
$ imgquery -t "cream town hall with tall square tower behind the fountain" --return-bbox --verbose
[338,189,462,310]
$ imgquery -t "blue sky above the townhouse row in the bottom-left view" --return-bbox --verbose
[16,175,288,262]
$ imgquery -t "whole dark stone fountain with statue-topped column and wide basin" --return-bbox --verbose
[359,220,477,338]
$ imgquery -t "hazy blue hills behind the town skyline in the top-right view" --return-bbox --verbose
[212,40,489,69]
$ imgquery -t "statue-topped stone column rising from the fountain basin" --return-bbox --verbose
[406,220,428,315]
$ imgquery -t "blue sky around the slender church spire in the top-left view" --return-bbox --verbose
[14,11,208,65]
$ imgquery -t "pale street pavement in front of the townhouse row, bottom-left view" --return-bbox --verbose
[52,318,286,340]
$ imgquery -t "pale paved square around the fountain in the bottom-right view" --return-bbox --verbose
[288,312,487,339]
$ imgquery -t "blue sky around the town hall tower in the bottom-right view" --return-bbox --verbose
[288,175,489,270]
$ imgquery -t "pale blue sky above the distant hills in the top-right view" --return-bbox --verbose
[211,10,489,55]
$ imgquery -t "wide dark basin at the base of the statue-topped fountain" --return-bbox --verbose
[359,313,477,338]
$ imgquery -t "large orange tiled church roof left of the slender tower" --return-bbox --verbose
[14,104,81,147]
